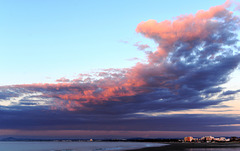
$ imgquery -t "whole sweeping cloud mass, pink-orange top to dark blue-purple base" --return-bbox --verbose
[0,1,240,133]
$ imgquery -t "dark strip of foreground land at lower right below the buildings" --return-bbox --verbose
[126,143,240,151]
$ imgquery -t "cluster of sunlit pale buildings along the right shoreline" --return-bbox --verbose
[184,136,230,142]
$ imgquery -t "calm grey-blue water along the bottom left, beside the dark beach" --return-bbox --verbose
[0,142,165,151]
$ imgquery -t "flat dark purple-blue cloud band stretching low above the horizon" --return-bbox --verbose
[0,109,239,131]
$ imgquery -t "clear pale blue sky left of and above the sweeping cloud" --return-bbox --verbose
[0,0,227,85]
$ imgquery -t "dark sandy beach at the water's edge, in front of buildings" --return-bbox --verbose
[127,142,240,151]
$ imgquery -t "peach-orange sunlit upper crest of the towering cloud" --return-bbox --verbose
[136,1,236,62]
